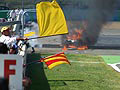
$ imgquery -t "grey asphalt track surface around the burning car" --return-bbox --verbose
[37,29,120,56]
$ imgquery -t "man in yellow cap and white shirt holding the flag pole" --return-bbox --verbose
[0,26,27,54]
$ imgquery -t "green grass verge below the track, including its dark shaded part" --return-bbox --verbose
[27,54,120,90]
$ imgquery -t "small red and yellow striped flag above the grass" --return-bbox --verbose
[42,52,70,69]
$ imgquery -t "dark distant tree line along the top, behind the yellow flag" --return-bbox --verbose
[0,0,86,9]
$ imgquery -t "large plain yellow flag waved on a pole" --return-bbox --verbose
[36,0,68,36]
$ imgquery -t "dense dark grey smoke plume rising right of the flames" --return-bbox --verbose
[82,0,116,45]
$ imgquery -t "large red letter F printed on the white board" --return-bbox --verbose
[4,60,16,79]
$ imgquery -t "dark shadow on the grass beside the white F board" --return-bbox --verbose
[26,54,50,90]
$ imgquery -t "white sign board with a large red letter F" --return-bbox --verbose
[0,54,23,90]
